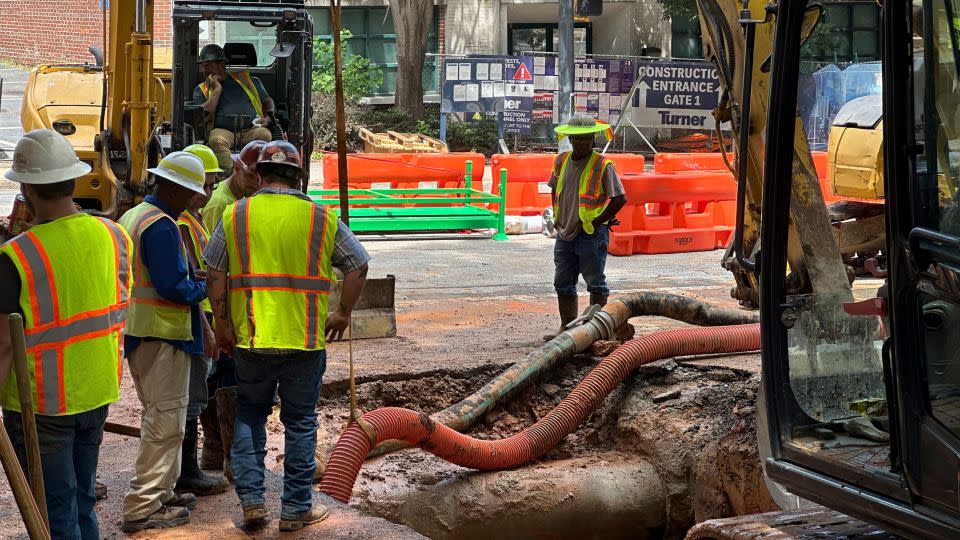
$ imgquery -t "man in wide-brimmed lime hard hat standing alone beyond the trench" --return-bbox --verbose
[544,114,627,341]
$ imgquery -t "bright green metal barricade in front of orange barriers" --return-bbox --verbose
[307,162,507,241]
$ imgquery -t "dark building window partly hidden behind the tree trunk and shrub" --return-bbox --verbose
[308,7,439,96]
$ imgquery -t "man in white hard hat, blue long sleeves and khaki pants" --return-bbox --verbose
[120,152,216,533]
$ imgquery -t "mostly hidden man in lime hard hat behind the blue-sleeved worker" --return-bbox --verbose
[175,144,227,497]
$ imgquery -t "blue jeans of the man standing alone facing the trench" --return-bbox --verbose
[553,225,610,296]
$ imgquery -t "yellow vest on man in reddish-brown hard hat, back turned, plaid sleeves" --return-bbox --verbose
[223,193,338,351]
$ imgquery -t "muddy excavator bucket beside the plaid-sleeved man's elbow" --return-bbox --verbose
[328,274,397,339]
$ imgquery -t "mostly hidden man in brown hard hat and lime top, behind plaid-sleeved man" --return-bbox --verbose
[198,137,267,482]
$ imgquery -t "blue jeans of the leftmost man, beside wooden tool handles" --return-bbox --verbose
[3,405,108,540]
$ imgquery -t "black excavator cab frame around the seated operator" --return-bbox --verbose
[169,0,313,179]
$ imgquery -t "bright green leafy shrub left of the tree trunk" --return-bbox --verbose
[313,29,383,98]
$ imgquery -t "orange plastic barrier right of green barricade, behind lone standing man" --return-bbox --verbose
[490,154,644,216]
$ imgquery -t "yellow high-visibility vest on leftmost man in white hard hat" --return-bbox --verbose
[0,214,133,416]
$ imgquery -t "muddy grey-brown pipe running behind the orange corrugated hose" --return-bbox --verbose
[369,292,760,457]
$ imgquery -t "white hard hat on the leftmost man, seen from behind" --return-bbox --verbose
[4,129,90,184]
